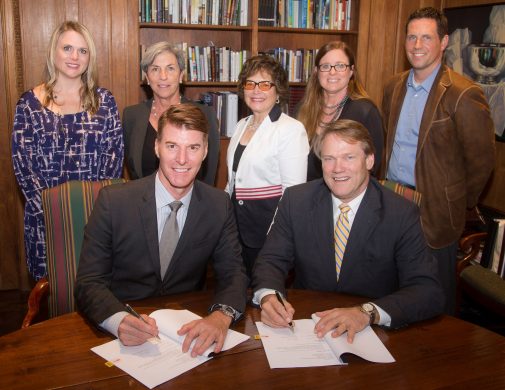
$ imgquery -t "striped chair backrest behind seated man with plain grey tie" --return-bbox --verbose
[42,179,126,317]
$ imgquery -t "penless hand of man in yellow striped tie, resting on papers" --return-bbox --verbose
[314,307,370,343]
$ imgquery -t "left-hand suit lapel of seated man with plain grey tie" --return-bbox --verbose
[139,174,161,279]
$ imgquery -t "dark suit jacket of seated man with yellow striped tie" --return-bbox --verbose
[253,179,444,327]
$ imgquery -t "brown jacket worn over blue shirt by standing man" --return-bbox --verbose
[380,65,495,248]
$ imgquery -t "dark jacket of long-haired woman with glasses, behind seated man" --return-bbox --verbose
[307,98,384,181]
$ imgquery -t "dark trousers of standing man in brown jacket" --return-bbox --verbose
[430,242,458,316]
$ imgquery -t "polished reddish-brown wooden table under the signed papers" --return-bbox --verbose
[0,290,505,390]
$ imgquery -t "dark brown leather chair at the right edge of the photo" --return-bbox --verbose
[456,232,505,318]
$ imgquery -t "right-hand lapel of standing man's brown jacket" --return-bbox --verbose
[416,65,451,160]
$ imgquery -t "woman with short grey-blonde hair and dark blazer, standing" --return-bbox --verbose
[123,42,219,185]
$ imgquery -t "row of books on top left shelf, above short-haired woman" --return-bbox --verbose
[139,0,249,26]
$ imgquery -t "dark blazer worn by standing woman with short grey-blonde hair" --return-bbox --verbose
[123,97,220,186]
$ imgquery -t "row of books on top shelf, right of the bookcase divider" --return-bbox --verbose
[258,0,352,30]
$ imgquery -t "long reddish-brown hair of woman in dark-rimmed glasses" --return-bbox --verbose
[297,41,369,142]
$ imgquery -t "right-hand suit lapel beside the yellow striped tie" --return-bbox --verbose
[339,179,381,286]
